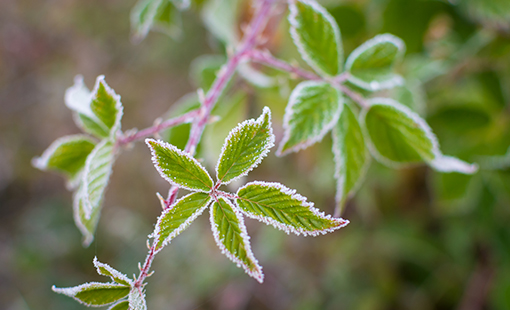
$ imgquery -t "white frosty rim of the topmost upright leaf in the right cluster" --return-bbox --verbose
[288,0,343,77]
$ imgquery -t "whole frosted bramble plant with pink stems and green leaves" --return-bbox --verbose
[33,0,492,310]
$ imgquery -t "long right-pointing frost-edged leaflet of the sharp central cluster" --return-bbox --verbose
[235,181,349,236]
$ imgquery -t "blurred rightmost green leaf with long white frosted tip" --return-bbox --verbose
[362,98,478,174]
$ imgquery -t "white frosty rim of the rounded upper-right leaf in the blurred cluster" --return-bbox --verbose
[345,33,406,91]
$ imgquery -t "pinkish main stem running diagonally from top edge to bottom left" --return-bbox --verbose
[134,0,275,288]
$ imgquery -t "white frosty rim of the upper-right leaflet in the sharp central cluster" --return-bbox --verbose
[215,106,275,185]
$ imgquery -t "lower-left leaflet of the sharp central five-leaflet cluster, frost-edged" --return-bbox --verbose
[152,193,211,250]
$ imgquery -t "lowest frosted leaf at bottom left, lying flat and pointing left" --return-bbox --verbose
[52,282,131,307]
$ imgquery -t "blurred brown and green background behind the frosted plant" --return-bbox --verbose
[0,0,510,310]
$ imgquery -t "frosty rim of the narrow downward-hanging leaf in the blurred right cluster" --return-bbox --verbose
[331,103,371,208]
